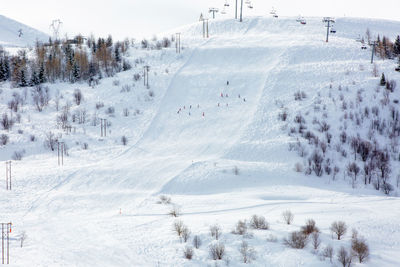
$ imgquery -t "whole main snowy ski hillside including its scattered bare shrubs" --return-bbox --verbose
[0,17,400,266]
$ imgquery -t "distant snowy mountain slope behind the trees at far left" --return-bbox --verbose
[0,15,49,47]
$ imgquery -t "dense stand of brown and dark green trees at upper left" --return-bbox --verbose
[0,36,131,87]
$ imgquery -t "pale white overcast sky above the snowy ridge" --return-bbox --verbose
[0,0,400,39]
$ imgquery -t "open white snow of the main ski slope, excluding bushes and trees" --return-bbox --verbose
[0,17,400,266]
